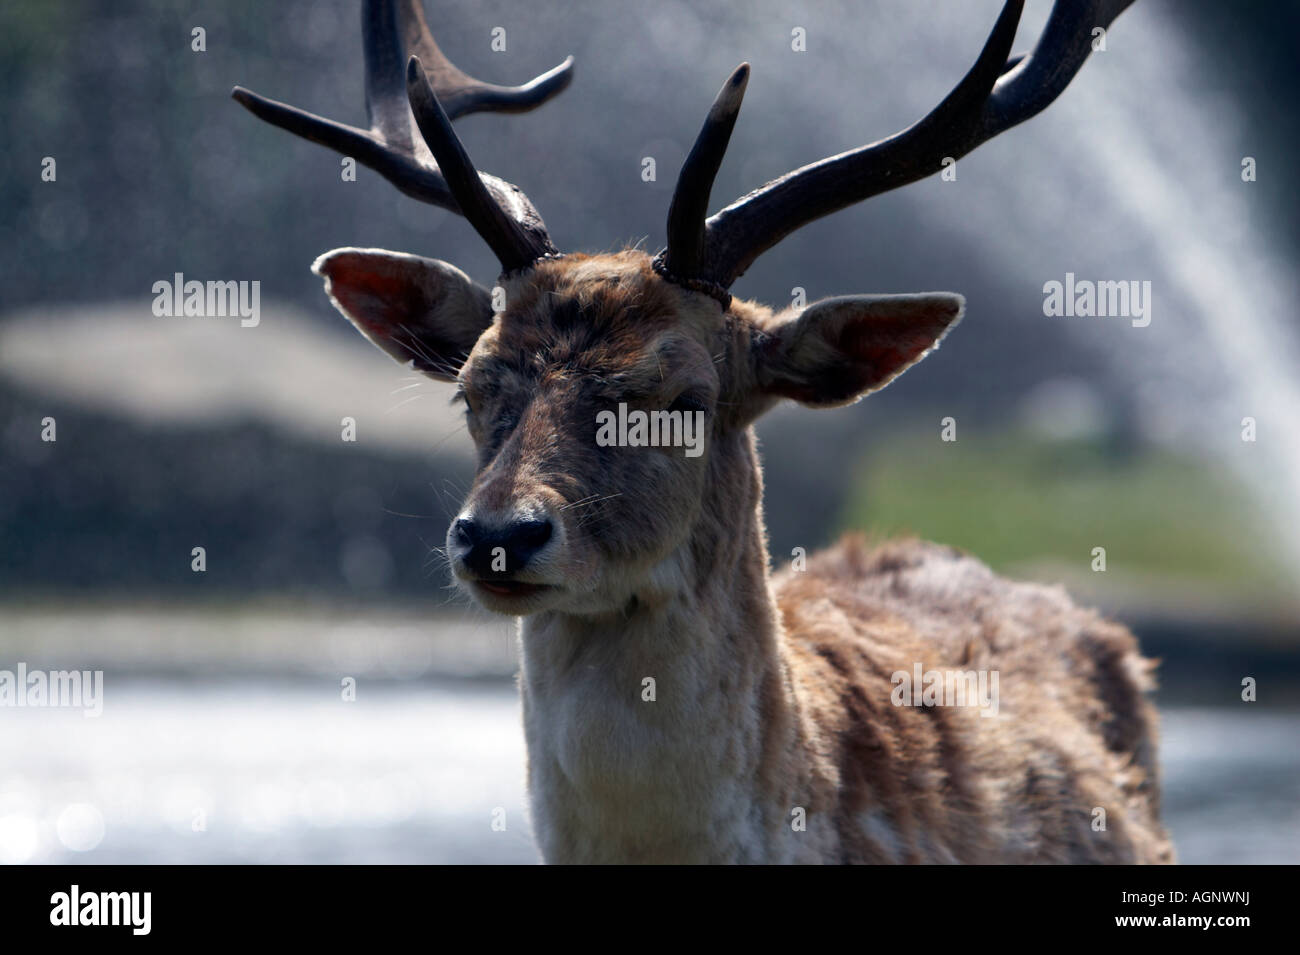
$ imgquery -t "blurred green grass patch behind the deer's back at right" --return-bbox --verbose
[841,431,1279,591]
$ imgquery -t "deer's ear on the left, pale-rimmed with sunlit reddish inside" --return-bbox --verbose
[312,248,493,381]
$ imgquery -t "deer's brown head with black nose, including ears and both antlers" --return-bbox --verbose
[234,0,1132,615]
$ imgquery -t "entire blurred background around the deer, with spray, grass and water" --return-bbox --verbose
[0,0,1300,863]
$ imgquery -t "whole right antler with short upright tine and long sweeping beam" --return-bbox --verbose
[655,0,1134,291]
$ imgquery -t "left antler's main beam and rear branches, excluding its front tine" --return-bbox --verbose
[231,0,573,272]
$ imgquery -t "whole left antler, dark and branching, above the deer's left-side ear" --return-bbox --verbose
[231,0,573,272]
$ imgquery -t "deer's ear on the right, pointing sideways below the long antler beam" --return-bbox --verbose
[754,292,966,408]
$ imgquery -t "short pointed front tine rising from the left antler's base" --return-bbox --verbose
[407,56,555,273]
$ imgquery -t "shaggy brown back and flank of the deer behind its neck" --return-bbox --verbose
[775,538,1173,863]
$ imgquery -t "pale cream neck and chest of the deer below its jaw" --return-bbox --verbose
[520,431,798,861]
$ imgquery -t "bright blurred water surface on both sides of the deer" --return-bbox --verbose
[0,677,1300,863]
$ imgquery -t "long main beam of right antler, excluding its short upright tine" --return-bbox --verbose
[690,0,1134,288]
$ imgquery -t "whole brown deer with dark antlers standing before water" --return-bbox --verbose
[233,0,1174,864]
